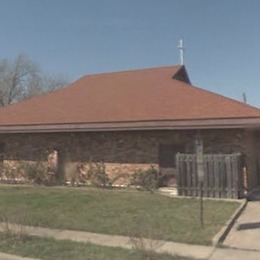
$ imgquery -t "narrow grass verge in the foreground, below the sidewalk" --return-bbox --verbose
[0,234,192,260]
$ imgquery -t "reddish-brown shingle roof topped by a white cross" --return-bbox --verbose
[0,63,260,131]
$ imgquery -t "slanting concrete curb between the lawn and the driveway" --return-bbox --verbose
[211,199,247,247]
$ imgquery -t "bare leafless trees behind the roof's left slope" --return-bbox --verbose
[0,55,68,107]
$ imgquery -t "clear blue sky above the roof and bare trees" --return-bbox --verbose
[0,0,260,107]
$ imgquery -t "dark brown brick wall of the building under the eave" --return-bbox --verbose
[0,129,260,190]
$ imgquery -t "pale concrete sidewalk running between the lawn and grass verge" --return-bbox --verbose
[0,223,260,260]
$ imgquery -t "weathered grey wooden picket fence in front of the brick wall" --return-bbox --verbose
[176,153,243,198]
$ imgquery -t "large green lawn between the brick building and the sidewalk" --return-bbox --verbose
[0,186,239,245]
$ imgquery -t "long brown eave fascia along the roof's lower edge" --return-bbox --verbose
[0,117,260,134]
